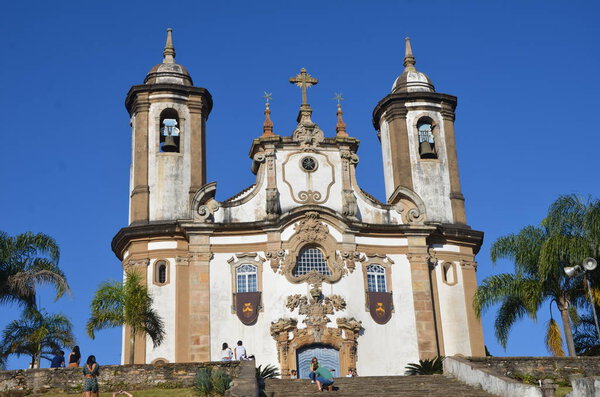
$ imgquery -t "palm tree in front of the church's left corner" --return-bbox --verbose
[87,271,165,364]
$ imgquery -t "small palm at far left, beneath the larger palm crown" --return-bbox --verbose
[0,307,75,368]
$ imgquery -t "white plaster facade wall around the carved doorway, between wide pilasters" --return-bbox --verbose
[210,246,418,376]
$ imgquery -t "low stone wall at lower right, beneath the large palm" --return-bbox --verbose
[468,357,600,384]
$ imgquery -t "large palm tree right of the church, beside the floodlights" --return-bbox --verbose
[473,195,600,356]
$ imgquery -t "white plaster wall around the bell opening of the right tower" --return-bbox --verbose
[406,109,453,223]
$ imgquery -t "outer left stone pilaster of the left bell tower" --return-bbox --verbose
[129,92,150,223]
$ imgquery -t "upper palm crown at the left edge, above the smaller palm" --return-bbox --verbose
[0,231,69,306]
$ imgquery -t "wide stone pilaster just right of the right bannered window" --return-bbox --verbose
[406,236,440,359]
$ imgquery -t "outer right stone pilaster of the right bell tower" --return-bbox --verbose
[442,103,467,225]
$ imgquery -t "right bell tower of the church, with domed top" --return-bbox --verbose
[373,38,466,224]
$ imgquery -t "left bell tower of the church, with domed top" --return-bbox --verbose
[125,29,212,225]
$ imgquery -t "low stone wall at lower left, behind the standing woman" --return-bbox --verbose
[0,361,245,397]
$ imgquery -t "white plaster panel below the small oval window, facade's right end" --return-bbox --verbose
[435,262,471,356]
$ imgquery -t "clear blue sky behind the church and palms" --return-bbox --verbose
[0,1,600,368]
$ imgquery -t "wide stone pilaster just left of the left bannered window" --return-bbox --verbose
[188,232,212,362]
